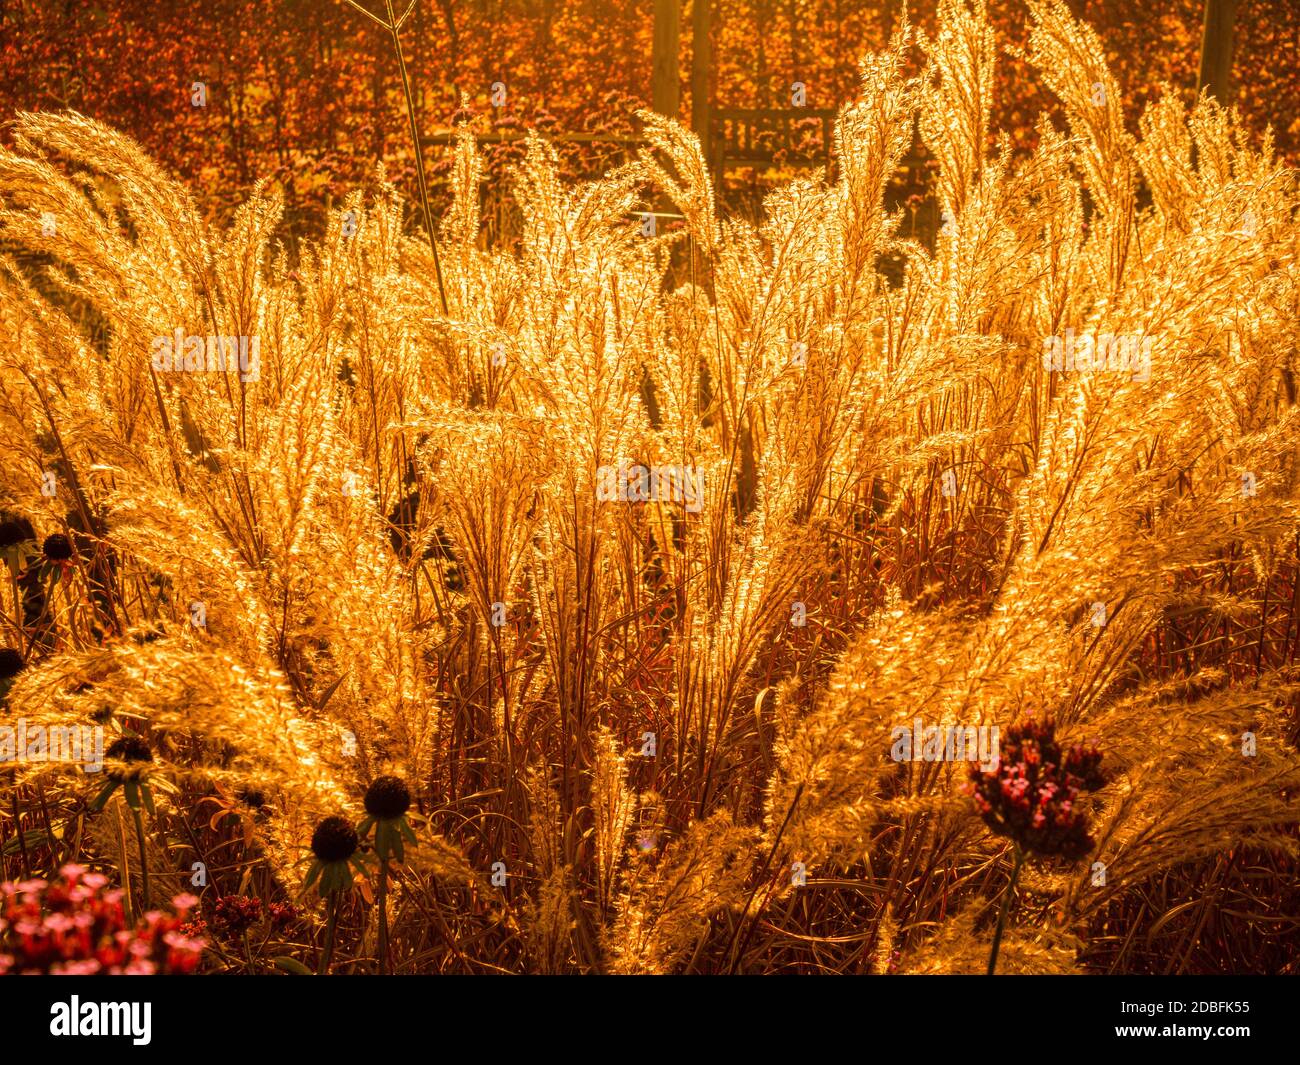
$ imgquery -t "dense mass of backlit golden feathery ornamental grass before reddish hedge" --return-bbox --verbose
[0,0,1300,973]
